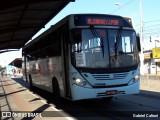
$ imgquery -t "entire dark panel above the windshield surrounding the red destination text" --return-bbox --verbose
[74,15,132,28]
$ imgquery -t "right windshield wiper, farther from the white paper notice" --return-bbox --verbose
[114,27,122,59]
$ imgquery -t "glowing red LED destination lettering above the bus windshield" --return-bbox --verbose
[86,18,119,26]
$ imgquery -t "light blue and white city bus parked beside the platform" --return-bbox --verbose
[22,14,140,101]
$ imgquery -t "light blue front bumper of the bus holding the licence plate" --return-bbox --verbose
[71,81,140,101]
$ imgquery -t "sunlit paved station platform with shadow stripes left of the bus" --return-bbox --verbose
[0,76,71,120]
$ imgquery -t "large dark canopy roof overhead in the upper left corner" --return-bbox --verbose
[0,0,75,53]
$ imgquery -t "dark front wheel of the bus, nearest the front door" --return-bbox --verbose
[52,79,62,107]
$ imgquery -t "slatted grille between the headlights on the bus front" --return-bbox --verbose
[92,72,128,80]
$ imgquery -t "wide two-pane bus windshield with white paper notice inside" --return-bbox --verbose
[72,28,138,68]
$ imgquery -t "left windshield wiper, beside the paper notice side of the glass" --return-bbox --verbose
[89,25,104,58]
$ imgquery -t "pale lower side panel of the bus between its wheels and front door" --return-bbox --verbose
[26,57,64,96]
